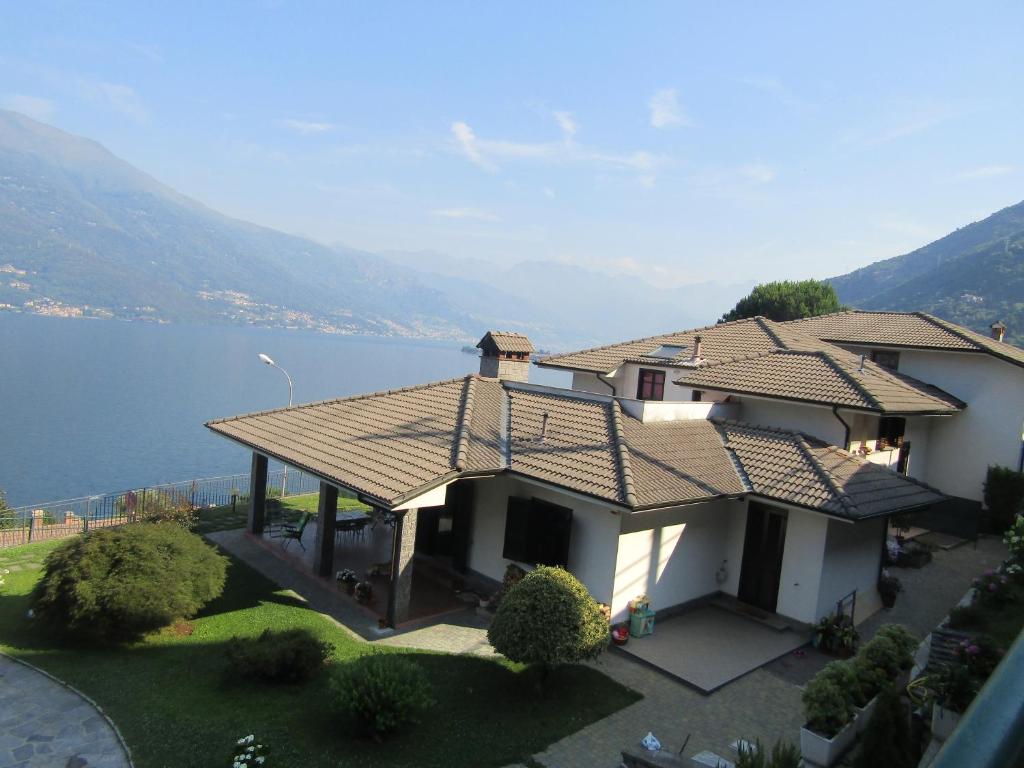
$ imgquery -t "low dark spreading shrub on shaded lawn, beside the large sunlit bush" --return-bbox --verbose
[225,630,332,684]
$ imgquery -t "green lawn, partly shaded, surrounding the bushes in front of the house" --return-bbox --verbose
[0,542,639,768]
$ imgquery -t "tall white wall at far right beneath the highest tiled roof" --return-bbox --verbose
[899,350,1024,501]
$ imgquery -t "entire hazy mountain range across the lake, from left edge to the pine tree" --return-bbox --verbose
[0,111,752,349]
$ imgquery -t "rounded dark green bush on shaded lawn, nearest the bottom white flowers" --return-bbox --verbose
[331,650,434,741]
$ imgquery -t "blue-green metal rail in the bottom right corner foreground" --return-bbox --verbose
[931,634,1024,768]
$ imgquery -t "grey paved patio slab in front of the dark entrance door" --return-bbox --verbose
[620,605,810,693]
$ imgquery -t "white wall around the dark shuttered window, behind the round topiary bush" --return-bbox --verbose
[469,476,620,603]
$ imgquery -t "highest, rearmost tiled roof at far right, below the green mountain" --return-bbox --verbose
[783,309,1024,366]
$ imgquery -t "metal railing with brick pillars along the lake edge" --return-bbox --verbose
[0,469,319,549]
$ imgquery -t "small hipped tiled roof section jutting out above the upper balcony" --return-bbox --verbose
[678,347,964,414]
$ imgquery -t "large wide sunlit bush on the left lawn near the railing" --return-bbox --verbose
[32,523,227,642]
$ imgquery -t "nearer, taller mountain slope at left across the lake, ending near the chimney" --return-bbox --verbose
[0,111,471,339]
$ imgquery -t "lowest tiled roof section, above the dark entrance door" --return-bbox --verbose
[719,422,945,520]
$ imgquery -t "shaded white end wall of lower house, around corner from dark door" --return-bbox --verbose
[817,519,886,624]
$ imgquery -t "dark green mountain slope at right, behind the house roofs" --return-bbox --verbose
[828,202,1024,344]
